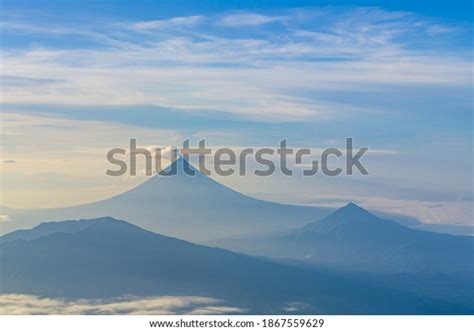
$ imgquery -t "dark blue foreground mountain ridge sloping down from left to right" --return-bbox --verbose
[0,217,473,314]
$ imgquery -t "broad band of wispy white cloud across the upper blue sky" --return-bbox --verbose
[2,8,472,122]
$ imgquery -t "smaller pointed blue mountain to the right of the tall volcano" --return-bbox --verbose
[212,203,474,307]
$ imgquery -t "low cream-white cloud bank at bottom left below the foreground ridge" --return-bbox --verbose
[0,294,245,315]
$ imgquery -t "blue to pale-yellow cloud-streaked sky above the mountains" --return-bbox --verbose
[0,0,473,224]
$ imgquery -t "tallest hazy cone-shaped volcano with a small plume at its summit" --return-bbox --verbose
[0,158,331,242]
